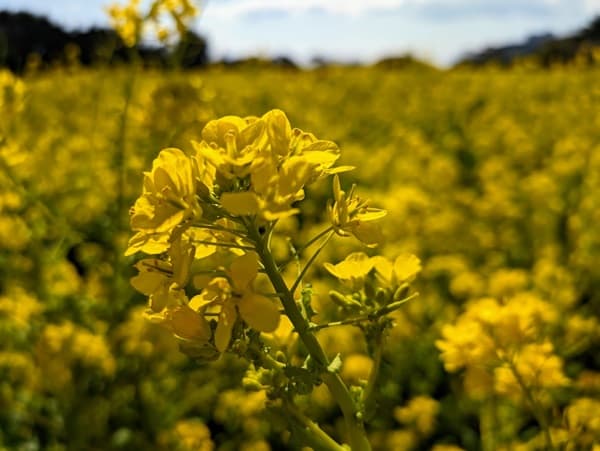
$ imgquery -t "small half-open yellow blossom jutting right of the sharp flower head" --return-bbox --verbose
[327,175,387,247]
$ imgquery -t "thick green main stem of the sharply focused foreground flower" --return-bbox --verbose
[247,222,371,451]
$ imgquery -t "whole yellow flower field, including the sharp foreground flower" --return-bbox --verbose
[0,64,600,451]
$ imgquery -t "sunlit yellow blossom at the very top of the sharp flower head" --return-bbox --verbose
[204,110,348,221]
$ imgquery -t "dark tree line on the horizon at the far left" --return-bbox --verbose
[0,11,207,72]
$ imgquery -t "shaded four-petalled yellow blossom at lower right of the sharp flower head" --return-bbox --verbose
[190,252,280,352]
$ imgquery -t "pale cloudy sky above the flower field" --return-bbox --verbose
[0,0,600,66]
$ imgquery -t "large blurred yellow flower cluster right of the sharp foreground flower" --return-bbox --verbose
[436,293,569,400]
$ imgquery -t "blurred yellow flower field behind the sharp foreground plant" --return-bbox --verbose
[0,52,600,451]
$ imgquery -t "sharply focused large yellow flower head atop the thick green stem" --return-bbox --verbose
[126,110,384,352]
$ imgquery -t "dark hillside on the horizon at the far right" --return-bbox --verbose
[458,16,600,66]
